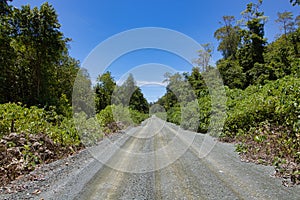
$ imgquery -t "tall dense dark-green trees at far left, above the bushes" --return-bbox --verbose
[0,2,79,107]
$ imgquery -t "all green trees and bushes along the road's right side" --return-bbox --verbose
[156,0,300,183]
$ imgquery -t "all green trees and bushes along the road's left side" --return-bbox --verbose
[0,0,149,185]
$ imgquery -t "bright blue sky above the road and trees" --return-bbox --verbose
[12,0,300,101]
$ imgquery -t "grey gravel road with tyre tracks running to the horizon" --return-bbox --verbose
[0,117,300,200]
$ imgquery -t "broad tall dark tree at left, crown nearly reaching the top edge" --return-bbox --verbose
[6,3,68,105]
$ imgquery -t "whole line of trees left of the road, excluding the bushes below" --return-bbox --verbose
[0,0,148,117]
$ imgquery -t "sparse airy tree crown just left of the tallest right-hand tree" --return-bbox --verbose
[214,16,240,59]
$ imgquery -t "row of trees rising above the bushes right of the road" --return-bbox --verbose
[158,0,300,110]
